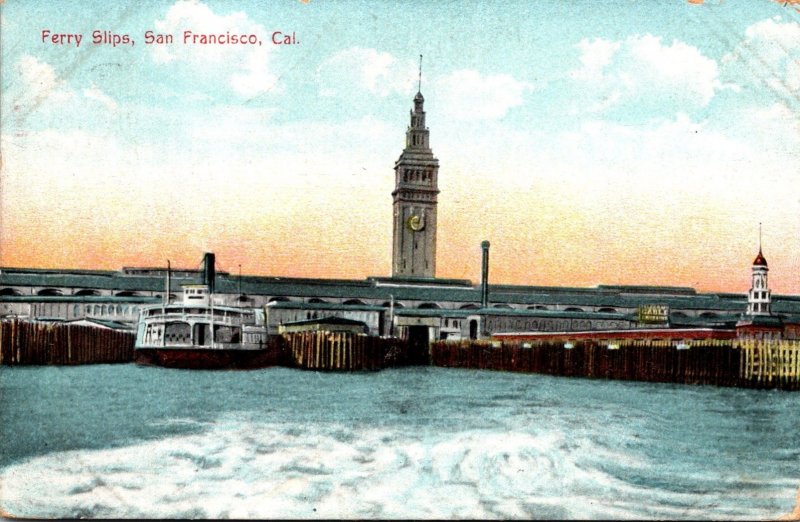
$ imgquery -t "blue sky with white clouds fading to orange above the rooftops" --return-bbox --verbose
[0,0,800,294]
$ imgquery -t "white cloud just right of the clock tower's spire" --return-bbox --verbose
[434,69,532,120]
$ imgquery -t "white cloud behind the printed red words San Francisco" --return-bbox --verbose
[151,0,277,97]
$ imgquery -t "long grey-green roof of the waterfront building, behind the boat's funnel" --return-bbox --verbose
[0,267,800,315]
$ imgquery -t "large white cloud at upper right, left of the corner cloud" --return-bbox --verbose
[569,34,722,118]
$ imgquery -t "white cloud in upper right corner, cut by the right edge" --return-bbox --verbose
[722,17,800,98]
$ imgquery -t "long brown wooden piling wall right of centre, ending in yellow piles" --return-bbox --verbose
[431,340,800,390]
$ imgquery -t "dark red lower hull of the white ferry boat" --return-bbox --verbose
[134,347,282,370]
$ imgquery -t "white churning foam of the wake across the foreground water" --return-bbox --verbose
[0,415,796,519]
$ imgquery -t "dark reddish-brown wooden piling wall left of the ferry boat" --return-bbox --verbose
[0,319,135,365]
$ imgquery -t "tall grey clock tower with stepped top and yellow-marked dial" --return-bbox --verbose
[392,75,439,277]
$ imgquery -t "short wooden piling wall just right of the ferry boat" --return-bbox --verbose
[283,331,409,371]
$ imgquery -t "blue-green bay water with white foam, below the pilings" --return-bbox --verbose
[0,365,800,519]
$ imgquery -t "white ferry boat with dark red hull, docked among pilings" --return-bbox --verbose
[134,284,280,369]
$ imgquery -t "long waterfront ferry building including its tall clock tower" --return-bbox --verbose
[0,87,800,343]
